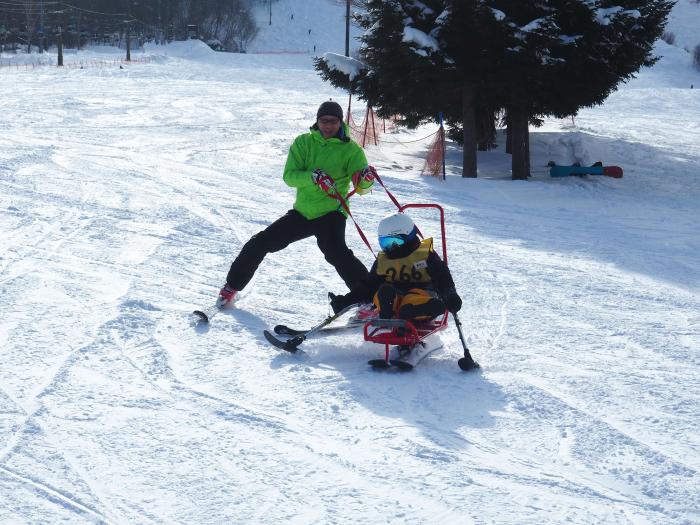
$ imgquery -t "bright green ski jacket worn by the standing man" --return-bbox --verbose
[284,123,373,219]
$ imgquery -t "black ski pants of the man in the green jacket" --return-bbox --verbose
[226,210,368,290]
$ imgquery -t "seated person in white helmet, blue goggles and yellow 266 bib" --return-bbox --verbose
[329,213,462,321]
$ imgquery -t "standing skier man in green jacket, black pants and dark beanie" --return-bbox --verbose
[219,101,376,303]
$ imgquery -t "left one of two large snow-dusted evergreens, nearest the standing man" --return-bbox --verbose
[316,0,493,177]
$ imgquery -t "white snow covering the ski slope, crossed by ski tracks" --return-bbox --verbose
[0,1,700,525]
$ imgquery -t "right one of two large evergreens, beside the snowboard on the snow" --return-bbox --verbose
[489,0,672,179]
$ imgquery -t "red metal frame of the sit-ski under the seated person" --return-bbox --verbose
[364,204,448,362]
